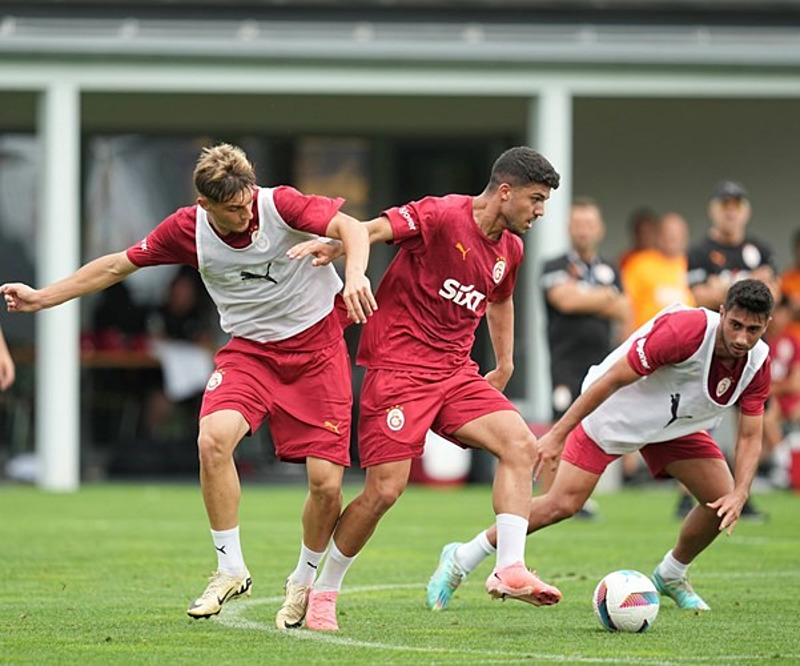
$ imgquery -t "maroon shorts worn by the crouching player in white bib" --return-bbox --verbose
[561,424,725,479]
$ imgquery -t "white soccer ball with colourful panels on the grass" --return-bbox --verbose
[592,569,659,633]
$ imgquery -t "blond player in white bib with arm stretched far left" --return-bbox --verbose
[0,144,376,628]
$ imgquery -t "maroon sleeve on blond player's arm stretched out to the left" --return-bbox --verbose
[126,207,197,268]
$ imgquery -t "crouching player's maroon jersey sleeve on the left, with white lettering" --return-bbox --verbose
[628,310,706,375]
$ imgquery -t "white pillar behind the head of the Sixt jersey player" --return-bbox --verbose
[525,86,572,421]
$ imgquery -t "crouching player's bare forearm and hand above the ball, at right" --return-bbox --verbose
[708,414,764,534]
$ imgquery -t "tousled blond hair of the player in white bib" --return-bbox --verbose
[194,143,256,203]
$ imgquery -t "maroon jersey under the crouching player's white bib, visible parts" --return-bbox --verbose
[628,308,770,416]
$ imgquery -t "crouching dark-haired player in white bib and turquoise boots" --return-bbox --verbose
[427,280,773,611]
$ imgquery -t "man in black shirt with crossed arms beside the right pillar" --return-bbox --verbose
[541,198,630,517]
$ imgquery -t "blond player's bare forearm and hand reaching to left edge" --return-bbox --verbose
[0,252,138,312]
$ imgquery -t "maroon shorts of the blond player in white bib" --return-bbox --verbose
[200,338,353,466]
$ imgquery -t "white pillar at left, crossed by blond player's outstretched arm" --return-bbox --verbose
[36,82,80,492]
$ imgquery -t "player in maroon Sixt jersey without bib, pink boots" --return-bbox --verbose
[296,147,561,630]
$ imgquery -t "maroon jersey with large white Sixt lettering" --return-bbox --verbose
[357,194,523,374]
